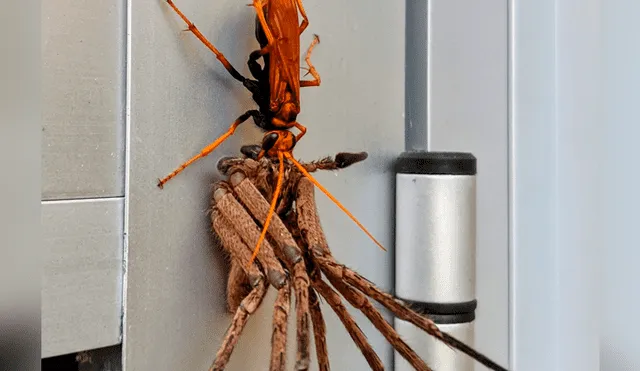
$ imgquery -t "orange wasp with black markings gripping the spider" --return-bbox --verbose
[158,0,384,261]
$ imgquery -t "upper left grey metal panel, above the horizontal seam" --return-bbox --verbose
[42,0,125,200]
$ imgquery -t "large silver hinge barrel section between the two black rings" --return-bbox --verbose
[395,174,476,303]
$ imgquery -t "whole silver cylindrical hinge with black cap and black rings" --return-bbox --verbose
[394,151,477,371]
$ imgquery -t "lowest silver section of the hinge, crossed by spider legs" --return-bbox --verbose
[394,318,472,371]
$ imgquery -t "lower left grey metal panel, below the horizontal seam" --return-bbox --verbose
[42,198,124,357]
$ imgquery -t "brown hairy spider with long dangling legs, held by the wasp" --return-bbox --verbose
[210,148,506,371]
